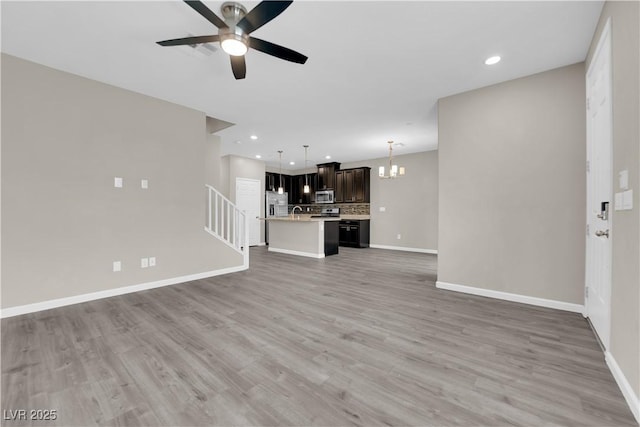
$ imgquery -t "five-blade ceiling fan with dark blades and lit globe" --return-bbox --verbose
[157,0,307,80]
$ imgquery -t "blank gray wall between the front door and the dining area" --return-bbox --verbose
[438,63,586,304]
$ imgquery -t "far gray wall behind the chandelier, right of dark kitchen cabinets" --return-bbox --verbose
[340,150,438,251]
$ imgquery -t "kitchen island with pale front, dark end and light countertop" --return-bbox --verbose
[267,215,340,258]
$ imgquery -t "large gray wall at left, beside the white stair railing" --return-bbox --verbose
[2,54,242,308]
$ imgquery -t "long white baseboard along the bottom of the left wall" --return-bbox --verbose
[0,265,248,319]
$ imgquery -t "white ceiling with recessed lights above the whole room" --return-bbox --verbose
[2,1,602,169]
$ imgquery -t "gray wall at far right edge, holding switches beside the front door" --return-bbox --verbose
[587,1,640,402]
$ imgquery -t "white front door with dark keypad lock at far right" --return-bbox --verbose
[585,21,613,349]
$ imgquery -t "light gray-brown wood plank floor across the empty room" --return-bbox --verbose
[2,248,635,426]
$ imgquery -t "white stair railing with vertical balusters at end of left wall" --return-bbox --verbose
[204,185,249,267]
